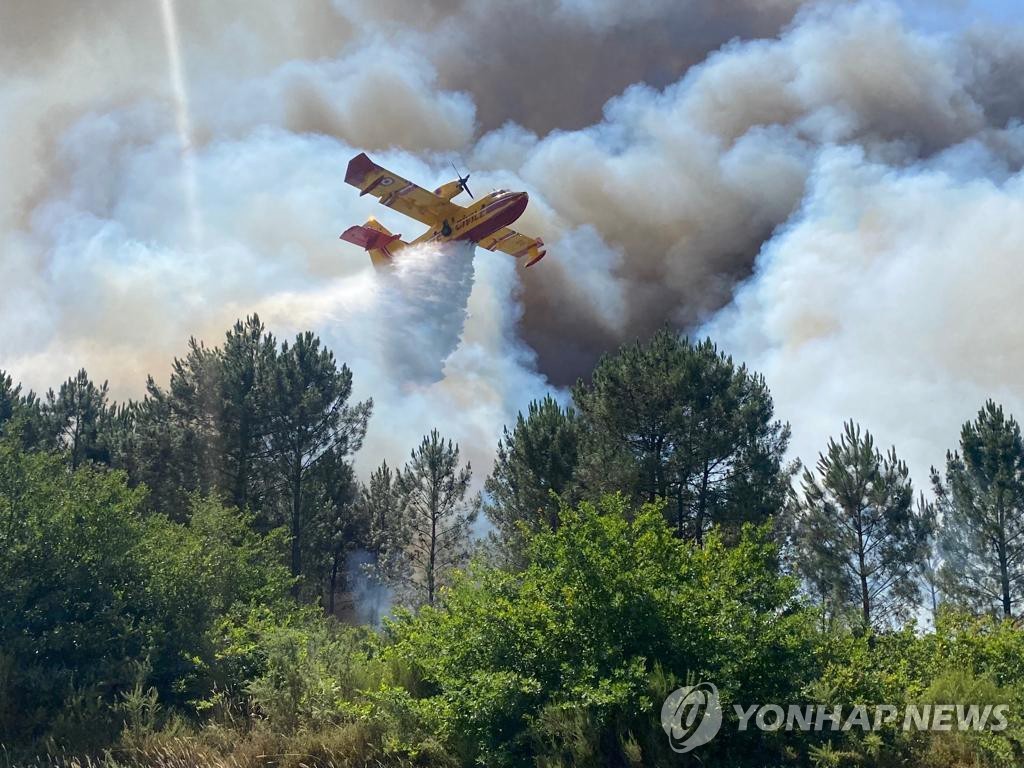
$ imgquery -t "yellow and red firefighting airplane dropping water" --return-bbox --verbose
[341,153,546,268]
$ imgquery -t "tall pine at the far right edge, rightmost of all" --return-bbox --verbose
[932,400,1024,618]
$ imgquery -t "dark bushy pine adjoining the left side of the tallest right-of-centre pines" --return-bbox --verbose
[484,395,580,547]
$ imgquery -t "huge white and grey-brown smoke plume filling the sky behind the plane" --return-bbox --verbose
[6,0,1024,493]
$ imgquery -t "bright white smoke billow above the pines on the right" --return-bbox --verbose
[702,142,1024,482]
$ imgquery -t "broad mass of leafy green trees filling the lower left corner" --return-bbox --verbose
[0,441,290,744]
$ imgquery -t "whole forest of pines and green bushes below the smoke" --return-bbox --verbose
[0,316,1024,768]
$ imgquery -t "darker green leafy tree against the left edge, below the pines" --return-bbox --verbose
[0,441,149,749]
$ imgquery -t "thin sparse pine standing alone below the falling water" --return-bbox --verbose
[395,429,478,605]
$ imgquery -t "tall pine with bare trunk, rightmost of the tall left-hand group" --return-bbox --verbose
[261,332,373,589]
